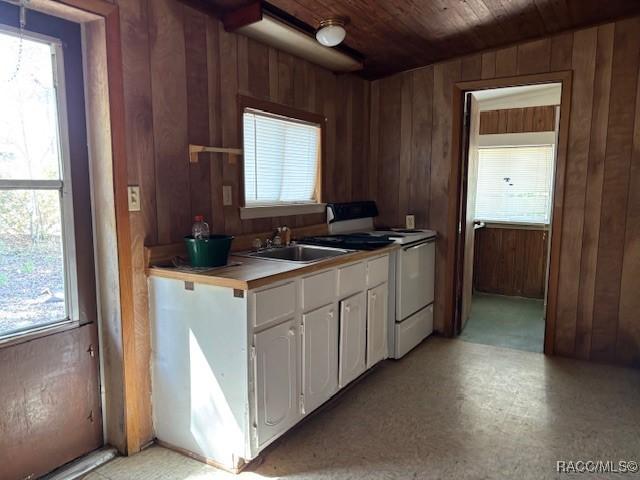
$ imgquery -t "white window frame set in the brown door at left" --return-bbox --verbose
[0,24,80,345]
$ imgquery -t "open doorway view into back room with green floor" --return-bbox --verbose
[457,82,562,353]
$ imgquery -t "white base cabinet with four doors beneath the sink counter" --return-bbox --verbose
[149,253,389,471]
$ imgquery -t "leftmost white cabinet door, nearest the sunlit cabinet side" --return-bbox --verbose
[254,319,300,447]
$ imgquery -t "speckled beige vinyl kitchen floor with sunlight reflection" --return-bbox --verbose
[87,337,640,480]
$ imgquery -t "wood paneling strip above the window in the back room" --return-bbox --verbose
[480,105,556,135]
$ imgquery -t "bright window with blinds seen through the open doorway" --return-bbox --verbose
[475,145,554,224]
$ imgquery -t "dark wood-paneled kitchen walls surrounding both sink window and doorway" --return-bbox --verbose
[109,0,640,450]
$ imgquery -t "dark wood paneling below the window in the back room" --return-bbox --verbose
[473,226,549,298]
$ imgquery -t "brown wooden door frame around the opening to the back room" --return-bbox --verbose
[445,70,573,355]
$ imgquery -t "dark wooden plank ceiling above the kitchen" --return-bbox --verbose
[190,0,640,79]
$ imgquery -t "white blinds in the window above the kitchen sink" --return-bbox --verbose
[243,109,321,207]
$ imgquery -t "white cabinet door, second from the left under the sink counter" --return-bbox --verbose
[302,304,338,413]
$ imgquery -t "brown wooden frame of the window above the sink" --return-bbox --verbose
[238,95,327,220]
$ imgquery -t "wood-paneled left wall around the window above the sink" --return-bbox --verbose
[117,0,369,443]
